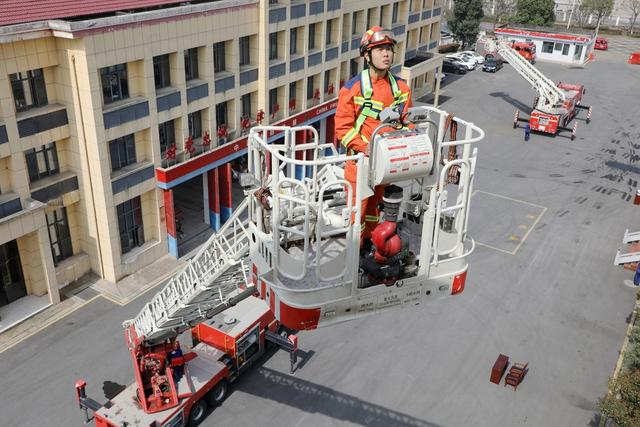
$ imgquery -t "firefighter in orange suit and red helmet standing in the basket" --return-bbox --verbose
[335,26,411,249]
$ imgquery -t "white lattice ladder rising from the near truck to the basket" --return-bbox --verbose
[123,199,254,343]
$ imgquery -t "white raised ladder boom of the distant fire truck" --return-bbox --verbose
[487,39,566,114]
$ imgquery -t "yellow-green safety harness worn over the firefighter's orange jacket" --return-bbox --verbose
[342,69,409,148]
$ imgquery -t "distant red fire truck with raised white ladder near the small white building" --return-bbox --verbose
[485,39,593,140]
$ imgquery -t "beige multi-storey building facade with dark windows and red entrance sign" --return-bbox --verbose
[0,0,442,326]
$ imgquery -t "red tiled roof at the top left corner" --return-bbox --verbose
[0,0,184,26]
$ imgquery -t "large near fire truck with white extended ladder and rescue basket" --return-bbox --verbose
[76,107,484,427]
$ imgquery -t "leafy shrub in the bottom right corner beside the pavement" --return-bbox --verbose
[598,369,640,427]
